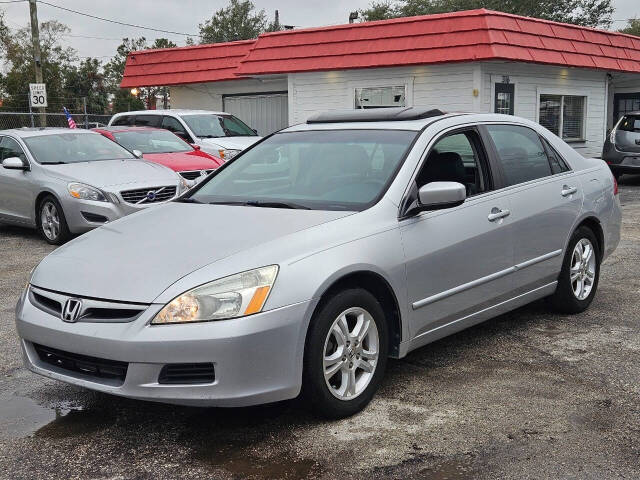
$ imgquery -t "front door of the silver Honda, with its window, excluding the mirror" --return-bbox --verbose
[400,128,514,338]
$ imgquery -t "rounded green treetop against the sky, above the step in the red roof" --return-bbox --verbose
[199,0,267,43]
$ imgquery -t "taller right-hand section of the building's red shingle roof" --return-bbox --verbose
[236,9,640,76]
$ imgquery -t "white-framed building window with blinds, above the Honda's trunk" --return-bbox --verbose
[540,95,587,141]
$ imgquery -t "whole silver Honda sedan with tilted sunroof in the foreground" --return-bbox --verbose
[16,108,621,418]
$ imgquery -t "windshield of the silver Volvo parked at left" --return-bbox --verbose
[24,132,135,165]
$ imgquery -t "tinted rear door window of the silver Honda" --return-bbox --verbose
[487,125,551,185]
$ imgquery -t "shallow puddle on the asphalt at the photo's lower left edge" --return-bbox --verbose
[0,392,114,438]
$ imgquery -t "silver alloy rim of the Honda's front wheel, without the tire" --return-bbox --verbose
[323,307,380,400]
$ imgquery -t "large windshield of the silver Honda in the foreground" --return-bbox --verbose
[188,130,417,211]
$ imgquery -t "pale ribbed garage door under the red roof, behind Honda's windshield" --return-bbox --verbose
[223,92,289,136]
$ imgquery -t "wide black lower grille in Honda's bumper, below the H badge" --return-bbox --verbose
[33,343,129,383]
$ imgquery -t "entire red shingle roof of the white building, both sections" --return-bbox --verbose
[121,9,640,87]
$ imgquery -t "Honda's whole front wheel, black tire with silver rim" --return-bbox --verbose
[302,288,388,419]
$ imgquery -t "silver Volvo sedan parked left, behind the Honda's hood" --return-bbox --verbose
[0,128,188,244]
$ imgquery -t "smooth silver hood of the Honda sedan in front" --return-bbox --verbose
[31,202,352,303]
